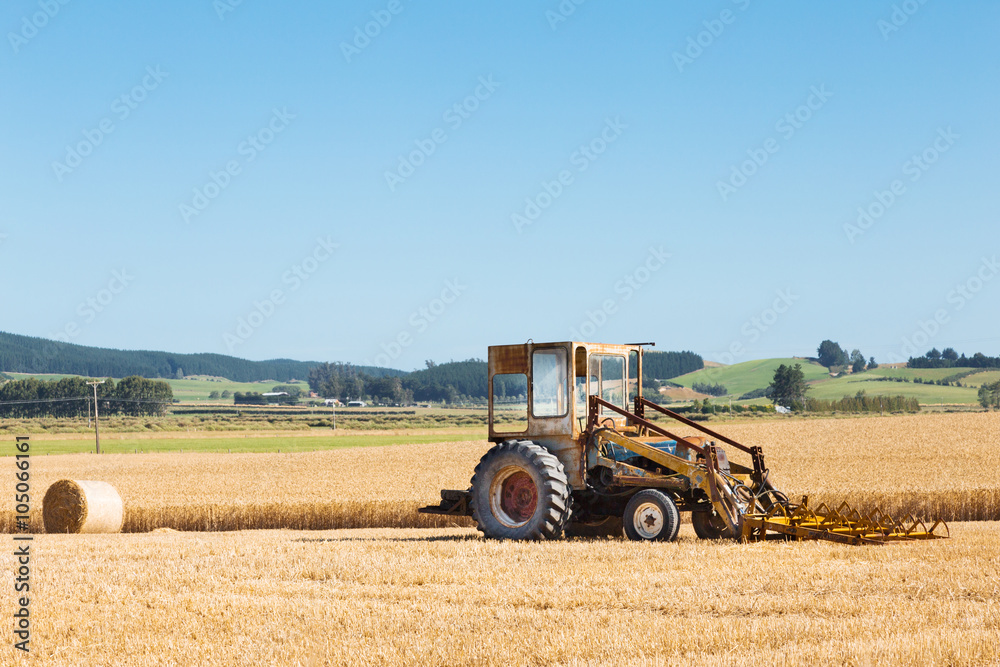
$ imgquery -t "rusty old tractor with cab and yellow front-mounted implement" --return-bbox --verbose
[420,341,947,544]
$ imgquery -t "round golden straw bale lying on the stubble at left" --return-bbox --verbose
[42,479,124,533]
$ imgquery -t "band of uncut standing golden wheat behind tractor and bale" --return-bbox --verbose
[3,413,1000,532]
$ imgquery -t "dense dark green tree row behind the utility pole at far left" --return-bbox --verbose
[0,375,174,419]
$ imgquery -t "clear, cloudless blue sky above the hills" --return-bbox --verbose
[0,0,1000,370]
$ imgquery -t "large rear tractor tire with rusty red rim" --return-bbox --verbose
[471,440,572,540]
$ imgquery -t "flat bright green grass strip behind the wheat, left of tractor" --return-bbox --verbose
[4,428,486,456]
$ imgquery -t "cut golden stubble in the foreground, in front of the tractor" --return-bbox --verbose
[0,523,1000,667]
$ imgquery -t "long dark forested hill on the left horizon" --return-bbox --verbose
[0,332,398,382]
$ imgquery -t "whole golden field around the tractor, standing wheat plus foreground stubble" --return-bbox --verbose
[0,413,1000,667]
